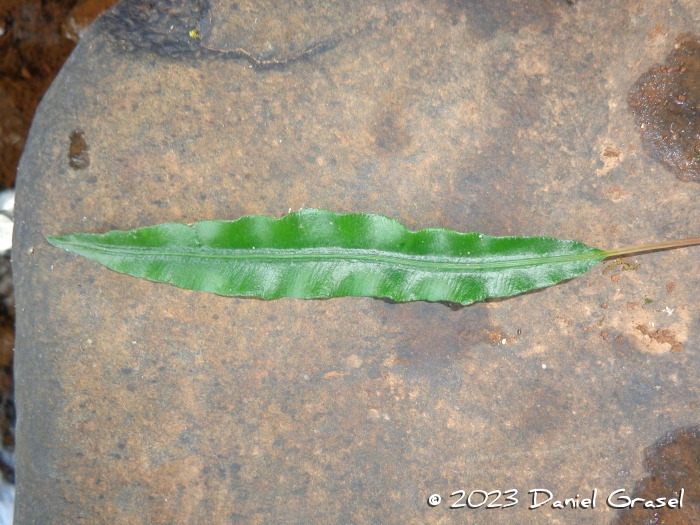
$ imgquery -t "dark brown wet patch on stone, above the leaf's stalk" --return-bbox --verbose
[629,34,700,182]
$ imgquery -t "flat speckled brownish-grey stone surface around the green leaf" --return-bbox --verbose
[13,0,700,525]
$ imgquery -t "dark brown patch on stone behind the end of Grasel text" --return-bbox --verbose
[613,427,700,525]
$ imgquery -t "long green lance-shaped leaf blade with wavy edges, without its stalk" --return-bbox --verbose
[47,209,609,304]
